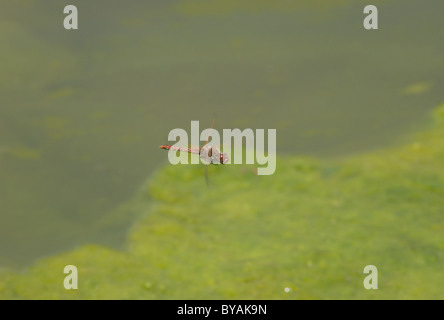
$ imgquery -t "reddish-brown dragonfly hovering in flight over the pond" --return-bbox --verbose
[159,116,230,186]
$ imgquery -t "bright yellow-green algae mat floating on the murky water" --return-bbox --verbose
[0,104,444,299]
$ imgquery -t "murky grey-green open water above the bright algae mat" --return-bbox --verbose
[0,0,444,265]
